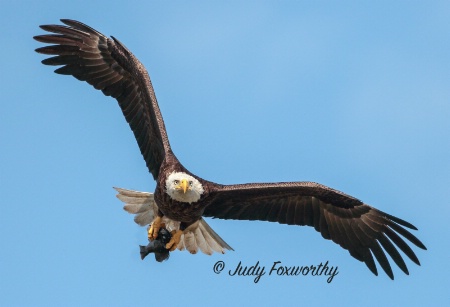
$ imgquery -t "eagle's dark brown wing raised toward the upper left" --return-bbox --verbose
[34,19,170,179]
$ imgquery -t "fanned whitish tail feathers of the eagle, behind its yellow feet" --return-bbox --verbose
[114,188,233,255]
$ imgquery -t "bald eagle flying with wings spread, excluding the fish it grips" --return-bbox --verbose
[34,19,426,279]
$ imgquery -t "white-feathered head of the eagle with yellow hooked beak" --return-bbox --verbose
[166,172,204,203]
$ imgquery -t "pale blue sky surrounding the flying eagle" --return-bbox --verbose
[0,0,450,306]
